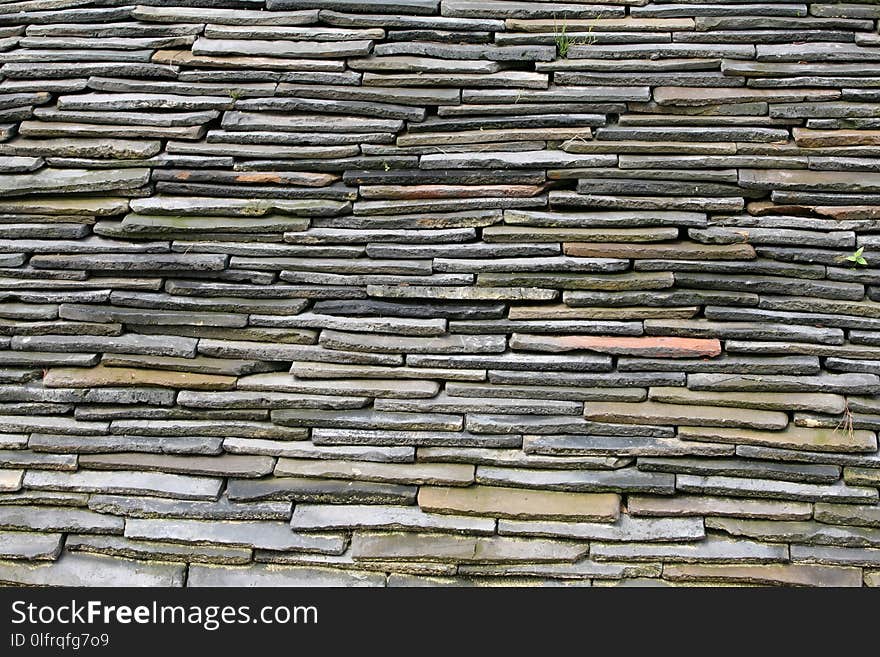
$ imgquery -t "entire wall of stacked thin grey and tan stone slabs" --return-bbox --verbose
[0,0,880,586]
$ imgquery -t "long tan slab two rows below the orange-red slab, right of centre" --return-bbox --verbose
[584,401,788,430]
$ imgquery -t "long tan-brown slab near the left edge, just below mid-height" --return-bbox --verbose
[43,365,236,390]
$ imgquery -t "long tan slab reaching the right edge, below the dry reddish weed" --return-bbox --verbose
[678,426,877,452]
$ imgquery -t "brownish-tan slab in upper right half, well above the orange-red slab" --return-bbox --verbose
[562,242,755,260]
